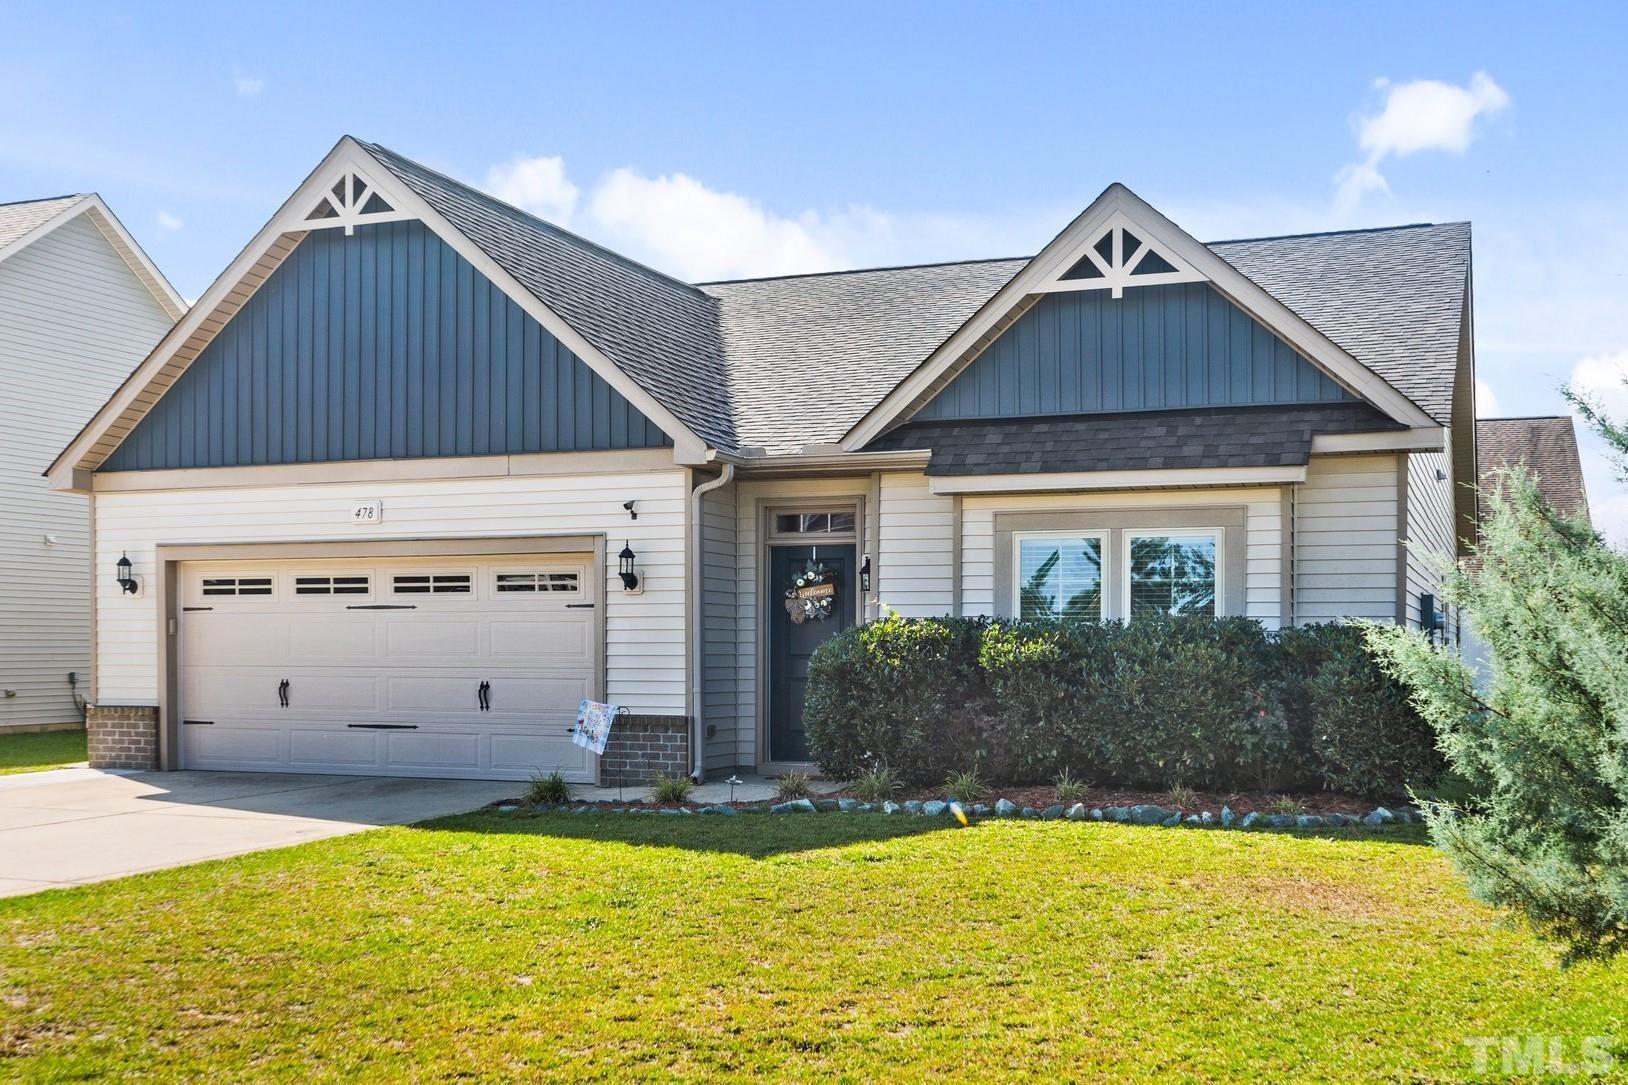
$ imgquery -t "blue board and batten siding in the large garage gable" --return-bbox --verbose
[103,222,672,471]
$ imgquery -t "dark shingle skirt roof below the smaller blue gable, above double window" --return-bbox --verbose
[871,402,1400,474]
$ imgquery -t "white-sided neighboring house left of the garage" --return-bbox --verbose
[0,195,186,731]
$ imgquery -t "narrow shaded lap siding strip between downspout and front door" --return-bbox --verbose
[702,485,747,771]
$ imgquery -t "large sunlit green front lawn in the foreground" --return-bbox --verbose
[0,813,1628,1082]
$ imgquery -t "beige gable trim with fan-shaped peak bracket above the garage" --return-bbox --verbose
[46,135,707,492]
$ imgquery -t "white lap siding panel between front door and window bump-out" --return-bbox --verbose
[876,472,956,617]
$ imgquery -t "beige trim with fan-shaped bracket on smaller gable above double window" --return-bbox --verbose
[842,182,1436,451]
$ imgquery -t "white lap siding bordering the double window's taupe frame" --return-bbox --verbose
[961,485,1283,629]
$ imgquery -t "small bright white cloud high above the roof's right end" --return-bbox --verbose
[1335,72,1509,210]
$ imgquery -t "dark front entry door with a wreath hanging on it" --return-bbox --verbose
[767,543,855,762]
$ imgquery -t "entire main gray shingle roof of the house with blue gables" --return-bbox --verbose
[353,143,1470,453]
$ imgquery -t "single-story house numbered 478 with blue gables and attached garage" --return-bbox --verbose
[50,137,1475,782]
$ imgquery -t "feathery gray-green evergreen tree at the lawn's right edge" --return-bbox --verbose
[1368,452,1628,961]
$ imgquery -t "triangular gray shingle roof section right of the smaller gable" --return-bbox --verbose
[1210,222,1470,425]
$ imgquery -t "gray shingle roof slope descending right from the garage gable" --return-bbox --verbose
[361,143,737,448]
